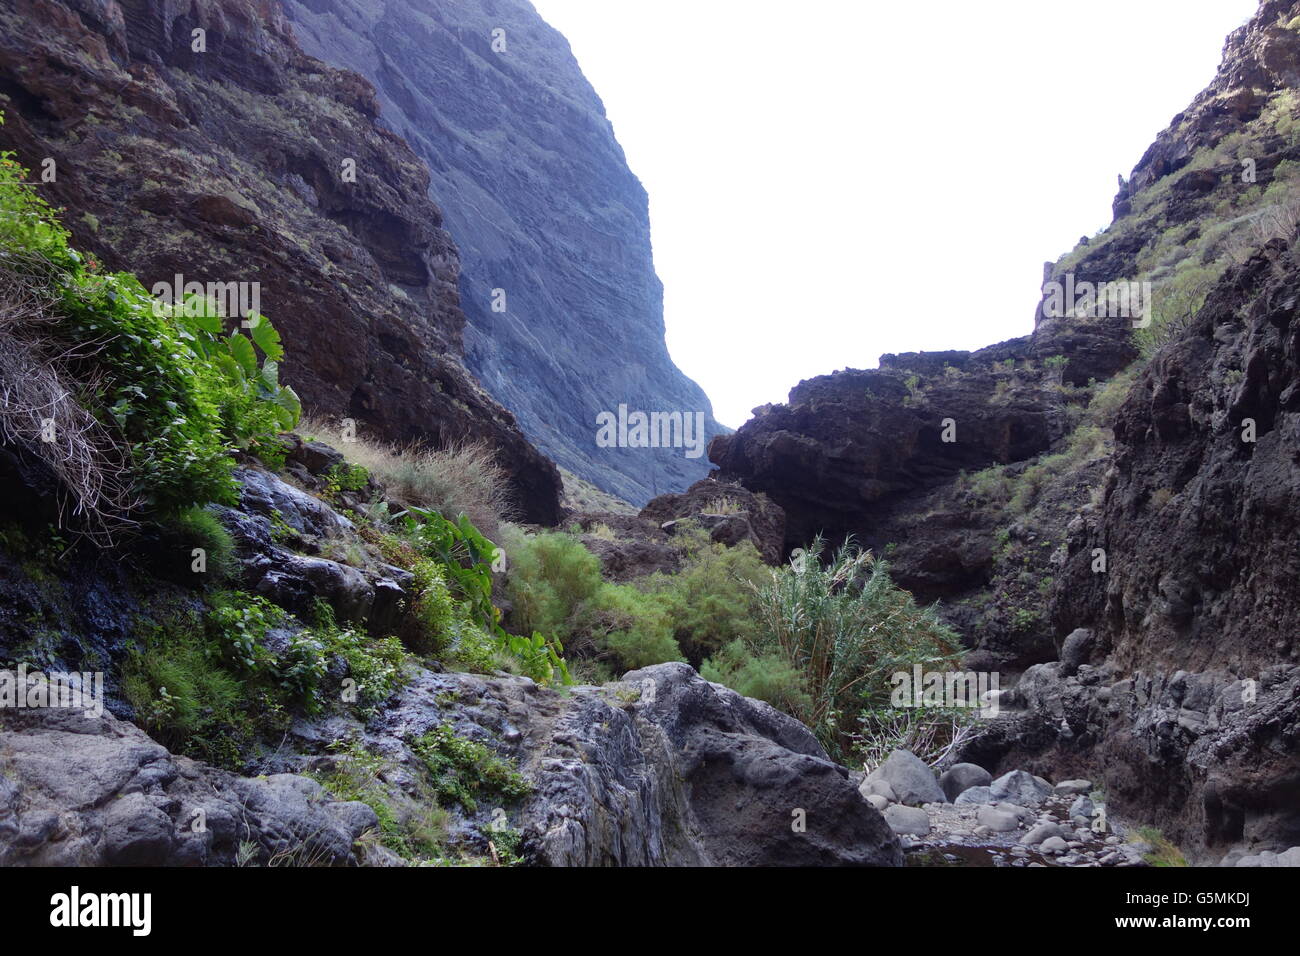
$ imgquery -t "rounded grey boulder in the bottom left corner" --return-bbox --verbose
[0,708,378,866]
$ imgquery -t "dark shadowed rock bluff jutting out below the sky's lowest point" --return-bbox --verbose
[709,339,1063,548]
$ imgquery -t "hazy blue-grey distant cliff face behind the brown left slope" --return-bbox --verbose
[285,0,722,505]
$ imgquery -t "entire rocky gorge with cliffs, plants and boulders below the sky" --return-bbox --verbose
[0,0,1300,868]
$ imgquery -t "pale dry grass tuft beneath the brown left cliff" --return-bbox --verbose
[298,418,514,540]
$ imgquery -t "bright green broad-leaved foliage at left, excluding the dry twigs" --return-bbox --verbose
[0,130,300,514]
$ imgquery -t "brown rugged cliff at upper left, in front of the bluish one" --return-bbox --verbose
[0,0,559,523]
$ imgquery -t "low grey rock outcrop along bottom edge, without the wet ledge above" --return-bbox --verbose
[0,665,902,866]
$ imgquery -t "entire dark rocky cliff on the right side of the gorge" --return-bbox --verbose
[710,1,1300,861]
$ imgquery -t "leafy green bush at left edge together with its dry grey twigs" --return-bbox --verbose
[0,121,300,530]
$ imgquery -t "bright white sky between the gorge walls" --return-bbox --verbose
[533,0,1257,427]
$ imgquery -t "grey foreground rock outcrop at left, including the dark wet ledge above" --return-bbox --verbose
[0,442,902,866]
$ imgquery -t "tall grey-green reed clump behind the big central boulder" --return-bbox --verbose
[709,538,959,754]
